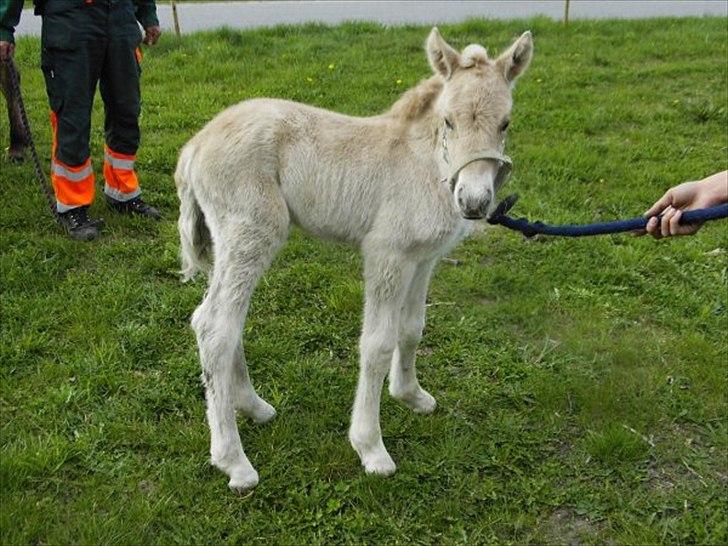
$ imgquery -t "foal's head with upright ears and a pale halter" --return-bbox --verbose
[427,28,533,219]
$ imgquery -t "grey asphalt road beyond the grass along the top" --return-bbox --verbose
[11,0,728,36]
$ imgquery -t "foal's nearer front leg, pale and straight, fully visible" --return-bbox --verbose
[349,256,414,476]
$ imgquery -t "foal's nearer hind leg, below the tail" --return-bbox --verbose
[192,206,288,491]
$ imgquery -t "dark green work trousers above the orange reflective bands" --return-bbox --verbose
[41,0,142,166]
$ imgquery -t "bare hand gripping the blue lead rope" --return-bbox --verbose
[645,171,728,239]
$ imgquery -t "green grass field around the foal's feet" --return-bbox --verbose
[0,14,728,545]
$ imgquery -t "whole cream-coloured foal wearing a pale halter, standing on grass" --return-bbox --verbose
[175,28,533,491]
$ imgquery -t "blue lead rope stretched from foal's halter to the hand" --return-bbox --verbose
[488,194,728,237]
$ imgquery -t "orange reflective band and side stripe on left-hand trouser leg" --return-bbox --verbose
[51,112,94,207]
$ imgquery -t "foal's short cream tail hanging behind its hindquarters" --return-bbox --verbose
[174,144,212,282]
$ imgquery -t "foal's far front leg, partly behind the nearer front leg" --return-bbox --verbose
[389,261,437,413]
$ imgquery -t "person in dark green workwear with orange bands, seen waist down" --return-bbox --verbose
[0,0,161,241]
